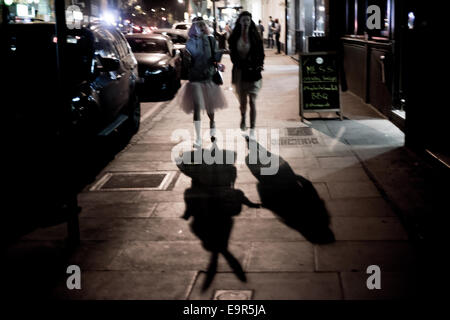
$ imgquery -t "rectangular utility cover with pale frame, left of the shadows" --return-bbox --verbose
[90,171,175,191]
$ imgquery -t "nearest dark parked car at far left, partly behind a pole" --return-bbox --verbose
[4,23,140,134]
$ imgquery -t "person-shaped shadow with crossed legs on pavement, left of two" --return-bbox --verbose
[177,147,259,290]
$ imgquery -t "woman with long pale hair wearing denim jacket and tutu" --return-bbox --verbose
[178,17,227,148]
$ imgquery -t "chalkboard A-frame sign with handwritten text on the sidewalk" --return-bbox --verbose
[299,52,342,121]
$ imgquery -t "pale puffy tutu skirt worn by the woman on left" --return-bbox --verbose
[177,80,228,113]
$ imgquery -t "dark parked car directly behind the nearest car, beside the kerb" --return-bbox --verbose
[126,34,181,98]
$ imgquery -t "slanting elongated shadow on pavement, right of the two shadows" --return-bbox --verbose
[245,141,335,244]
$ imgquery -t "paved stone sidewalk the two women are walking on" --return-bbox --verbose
[4,51,424,300]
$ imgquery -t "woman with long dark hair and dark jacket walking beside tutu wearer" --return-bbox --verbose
[228,11,264,139]
